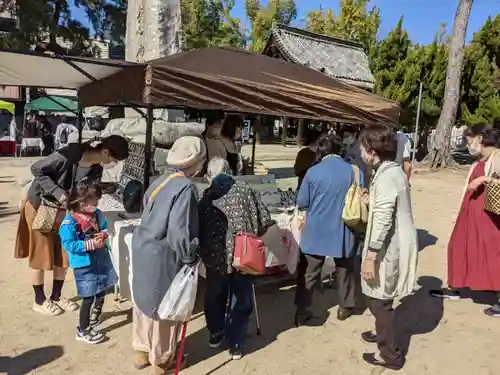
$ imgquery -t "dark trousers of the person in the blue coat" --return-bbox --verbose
[295,253,360,312]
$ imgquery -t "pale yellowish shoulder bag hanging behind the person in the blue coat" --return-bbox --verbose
[342,165,368,233]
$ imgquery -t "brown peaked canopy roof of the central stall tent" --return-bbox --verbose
[79,47,399,125]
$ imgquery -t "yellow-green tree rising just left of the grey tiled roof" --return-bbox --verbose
[245,0,297,53]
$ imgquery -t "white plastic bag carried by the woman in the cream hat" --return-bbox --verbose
[158,264,199,322]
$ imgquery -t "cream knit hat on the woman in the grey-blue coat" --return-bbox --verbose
[167,136,206,169]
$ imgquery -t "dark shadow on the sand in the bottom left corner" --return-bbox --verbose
[0,346,64,375]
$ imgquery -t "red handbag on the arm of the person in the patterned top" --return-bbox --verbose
[233,233,266,275]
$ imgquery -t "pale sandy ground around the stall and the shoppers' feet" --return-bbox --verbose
[0,146,500,375]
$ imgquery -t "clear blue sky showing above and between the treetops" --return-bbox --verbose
[71,0,500,44]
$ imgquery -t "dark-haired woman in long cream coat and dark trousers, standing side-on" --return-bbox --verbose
[360,125,418,370]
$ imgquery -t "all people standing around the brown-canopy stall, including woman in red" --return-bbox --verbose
[12,116,500,374]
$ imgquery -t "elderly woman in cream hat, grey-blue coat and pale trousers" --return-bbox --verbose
[131,136,206,375]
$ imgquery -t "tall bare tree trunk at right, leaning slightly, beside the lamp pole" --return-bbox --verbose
[431,0,474,168]
